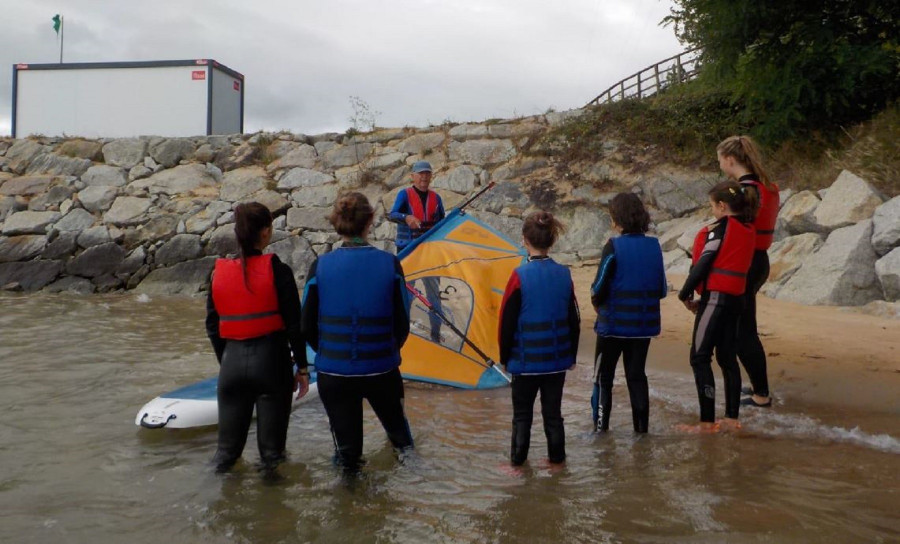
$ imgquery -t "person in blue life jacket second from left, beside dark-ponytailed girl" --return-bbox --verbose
[302,192,413,471]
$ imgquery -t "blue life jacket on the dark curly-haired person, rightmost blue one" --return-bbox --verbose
[594,234,666,338]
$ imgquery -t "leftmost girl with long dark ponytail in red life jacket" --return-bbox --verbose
[206,202,309,472]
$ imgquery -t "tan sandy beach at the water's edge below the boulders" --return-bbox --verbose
[572,265,900,432]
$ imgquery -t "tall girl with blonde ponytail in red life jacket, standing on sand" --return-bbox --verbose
[716,136,781,407]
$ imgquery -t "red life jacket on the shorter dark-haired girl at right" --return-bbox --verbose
[691,216,755,295]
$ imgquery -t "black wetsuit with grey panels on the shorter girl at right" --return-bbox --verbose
[678,217,743,423]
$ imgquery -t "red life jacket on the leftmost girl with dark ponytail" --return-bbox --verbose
[212,254,285,340]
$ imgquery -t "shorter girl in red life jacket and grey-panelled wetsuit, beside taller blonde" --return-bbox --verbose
[678,181,755,431]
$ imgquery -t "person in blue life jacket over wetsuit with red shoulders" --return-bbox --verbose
[500,212,581,466]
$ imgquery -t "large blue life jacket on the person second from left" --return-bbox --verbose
[316,246,400,376]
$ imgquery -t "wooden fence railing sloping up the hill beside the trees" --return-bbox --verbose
[587,49,700,106]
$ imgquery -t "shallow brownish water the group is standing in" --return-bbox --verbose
[0,294,900,544]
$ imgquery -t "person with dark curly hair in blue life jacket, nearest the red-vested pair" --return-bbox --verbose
[591,193,668,433]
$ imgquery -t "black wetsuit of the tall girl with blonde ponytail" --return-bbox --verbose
[737,174,769,397]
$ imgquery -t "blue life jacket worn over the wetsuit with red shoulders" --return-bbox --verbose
[507,259,578,374]
